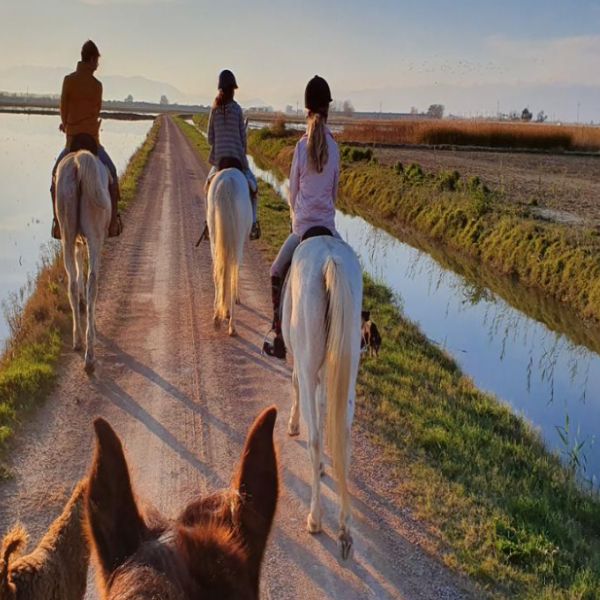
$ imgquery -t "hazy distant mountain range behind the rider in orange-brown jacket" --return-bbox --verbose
[0,66,209,104]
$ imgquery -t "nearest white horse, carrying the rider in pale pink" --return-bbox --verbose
[282,236,362,560]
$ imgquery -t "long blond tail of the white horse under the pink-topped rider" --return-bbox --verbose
[324,257,356,514]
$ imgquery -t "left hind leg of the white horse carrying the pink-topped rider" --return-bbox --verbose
[299,376,322,533]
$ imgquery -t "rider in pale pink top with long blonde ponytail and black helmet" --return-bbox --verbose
[263,75,340,359]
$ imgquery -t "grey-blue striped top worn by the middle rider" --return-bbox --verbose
[208,100,248,169]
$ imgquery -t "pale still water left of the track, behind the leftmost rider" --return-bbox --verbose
[0,114,152,348]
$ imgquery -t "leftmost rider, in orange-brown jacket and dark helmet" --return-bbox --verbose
[50,40,122,240]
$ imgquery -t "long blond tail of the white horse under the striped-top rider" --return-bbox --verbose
[211,175,243,319]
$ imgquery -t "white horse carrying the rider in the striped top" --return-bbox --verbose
[206,169,252,335]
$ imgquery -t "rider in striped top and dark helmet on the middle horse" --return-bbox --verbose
[203,69,260,240]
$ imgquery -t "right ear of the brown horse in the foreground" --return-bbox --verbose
[234,406,279,590]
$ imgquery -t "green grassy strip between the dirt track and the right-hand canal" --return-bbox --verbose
[180,116,600,600]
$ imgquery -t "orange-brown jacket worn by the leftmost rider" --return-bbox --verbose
[60,61,102,146]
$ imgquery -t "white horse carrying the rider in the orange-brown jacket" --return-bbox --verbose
[56,150,111,373]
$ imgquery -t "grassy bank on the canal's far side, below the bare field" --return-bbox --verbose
[249,129,600,320]
